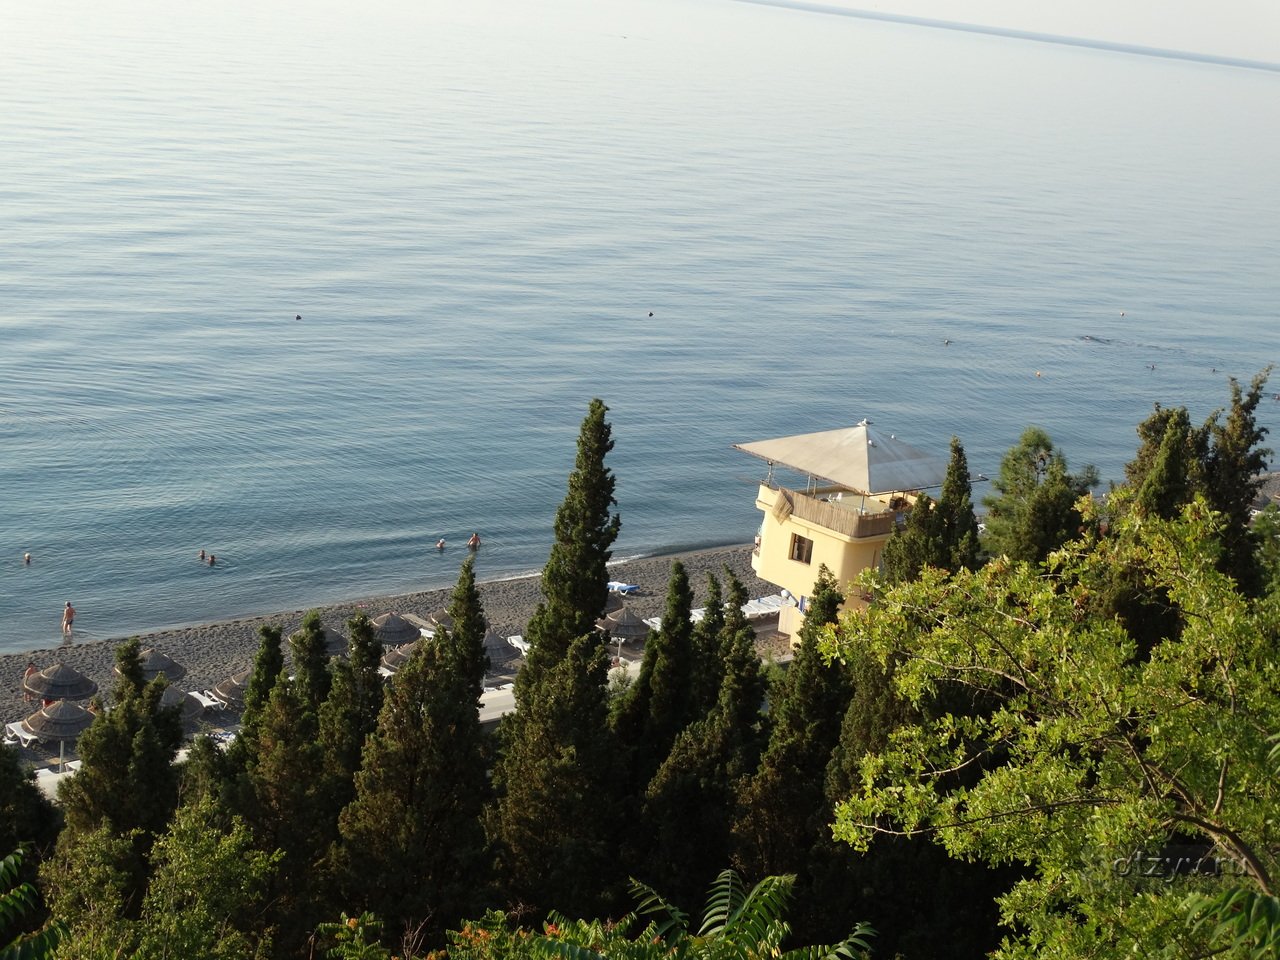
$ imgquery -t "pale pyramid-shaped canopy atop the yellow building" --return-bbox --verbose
[733,420,947,494]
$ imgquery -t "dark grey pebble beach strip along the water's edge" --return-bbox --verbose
[0,547,777,759]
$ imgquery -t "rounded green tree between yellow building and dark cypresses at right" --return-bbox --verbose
[983,426,1098,563]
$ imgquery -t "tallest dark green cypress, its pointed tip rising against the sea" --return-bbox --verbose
[489,399,621,914]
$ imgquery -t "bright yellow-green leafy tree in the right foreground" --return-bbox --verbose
[836,500,1280,957]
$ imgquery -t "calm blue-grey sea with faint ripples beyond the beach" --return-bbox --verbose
[0,0,1280,650]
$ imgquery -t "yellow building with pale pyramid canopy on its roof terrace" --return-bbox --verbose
[733,420,946,636]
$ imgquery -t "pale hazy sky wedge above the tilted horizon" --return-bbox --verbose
[817,0,1280,63]
